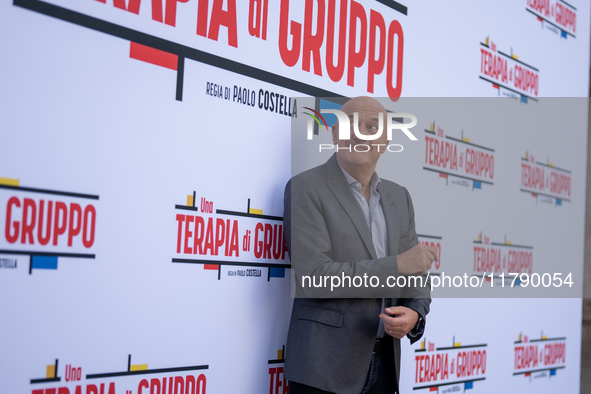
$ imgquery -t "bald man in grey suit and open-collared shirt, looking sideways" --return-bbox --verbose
[284,97,436,394]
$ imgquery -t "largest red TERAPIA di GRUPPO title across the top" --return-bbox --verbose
[82,0,407,101]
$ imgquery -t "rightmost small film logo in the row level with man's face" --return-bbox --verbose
[520,151,572,205]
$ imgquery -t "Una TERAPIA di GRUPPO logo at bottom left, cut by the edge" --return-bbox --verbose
[31,354,209,394]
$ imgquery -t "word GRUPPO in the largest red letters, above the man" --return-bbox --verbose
[279,0,406,101]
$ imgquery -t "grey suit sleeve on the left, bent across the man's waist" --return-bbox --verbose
[284,177,400,298]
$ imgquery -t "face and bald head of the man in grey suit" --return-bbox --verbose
[332,97,389,166]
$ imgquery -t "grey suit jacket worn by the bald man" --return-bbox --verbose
[284,155,431,394]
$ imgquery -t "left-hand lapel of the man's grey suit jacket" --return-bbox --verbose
[326,154,377,259]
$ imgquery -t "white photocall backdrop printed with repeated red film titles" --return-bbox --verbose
[0,0,590,394]
